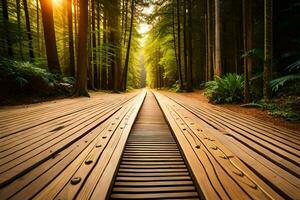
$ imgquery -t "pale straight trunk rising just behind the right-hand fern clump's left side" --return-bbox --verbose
[214,0,222,76]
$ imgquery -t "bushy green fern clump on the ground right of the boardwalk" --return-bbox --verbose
[204,73,244,103]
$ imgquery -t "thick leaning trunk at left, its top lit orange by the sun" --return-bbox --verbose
[40,0,61,73]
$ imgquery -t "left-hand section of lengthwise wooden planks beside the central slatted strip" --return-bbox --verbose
[0,91,145,199]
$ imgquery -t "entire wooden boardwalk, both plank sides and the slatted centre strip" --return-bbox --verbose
[0,90,300,200]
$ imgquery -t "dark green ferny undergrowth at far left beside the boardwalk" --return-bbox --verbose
[0,58,74,96]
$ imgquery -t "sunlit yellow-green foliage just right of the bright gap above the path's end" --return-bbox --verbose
[143,1,180,88]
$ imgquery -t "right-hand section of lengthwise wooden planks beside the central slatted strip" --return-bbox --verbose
[155,92,300,199]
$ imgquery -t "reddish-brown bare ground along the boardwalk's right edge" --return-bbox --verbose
[181,90,300,131]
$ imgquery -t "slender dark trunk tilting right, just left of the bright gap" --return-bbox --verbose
[122,0,135,91]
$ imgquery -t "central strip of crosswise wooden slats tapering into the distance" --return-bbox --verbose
[110,92,199,199]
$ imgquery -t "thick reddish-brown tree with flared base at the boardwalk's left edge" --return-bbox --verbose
[75,0,89,96]
